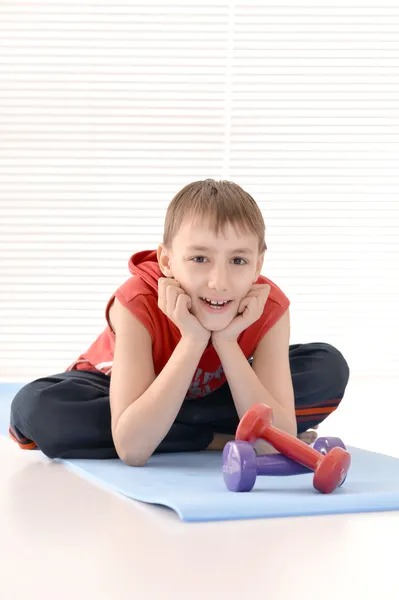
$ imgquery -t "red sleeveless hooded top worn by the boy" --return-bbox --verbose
[66,250,290,398]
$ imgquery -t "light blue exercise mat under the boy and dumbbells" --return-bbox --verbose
[0,385,399,521]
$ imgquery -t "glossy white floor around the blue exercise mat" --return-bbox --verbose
[0,383,399,600]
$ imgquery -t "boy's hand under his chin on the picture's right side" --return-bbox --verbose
[212,283,271,343]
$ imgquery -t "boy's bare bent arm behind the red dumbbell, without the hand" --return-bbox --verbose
[214,310,297,437]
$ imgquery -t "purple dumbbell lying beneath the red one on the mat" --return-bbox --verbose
[222,437,346,492]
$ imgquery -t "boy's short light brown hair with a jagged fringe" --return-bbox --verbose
[163,179,267,253]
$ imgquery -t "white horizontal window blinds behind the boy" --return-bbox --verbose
[0,0,399,381]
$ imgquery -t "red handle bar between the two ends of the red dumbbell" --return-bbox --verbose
[260,425,324,471]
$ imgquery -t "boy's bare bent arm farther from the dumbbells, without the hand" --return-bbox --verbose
[110,302,207,466]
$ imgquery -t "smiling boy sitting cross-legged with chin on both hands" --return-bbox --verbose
[9,179,349,466]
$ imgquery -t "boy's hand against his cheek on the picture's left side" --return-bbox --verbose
[158,277,211,344]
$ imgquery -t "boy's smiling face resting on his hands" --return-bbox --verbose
[158,219,264,331]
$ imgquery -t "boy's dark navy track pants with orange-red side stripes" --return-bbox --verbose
[10,342,349,458]
